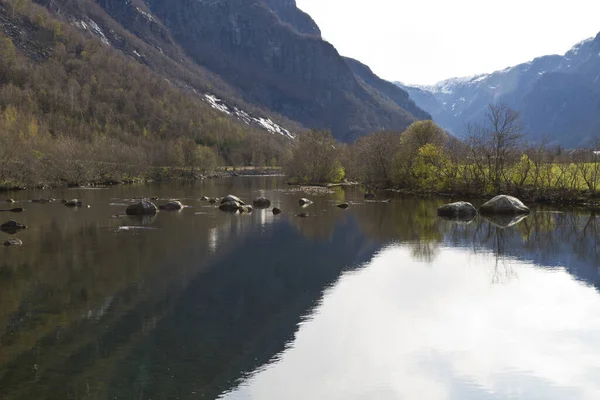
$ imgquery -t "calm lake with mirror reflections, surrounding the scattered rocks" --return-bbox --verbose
[0,177,600,400]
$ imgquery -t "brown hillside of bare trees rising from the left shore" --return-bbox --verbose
[0,0,287,186]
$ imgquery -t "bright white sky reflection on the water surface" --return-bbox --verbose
[224,246,600,400]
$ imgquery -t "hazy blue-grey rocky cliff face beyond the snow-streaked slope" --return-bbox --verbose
[137,0,426,141]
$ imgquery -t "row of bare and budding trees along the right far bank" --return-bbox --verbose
[285,104,600,200]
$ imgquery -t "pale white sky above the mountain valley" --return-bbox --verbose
[296,0,600,85]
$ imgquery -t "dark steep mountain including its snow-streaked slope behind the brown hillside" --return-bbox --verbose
[37,0,429,141]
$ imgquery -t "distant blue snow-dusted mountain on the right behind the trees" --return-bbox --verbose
[397,34,600,147]
